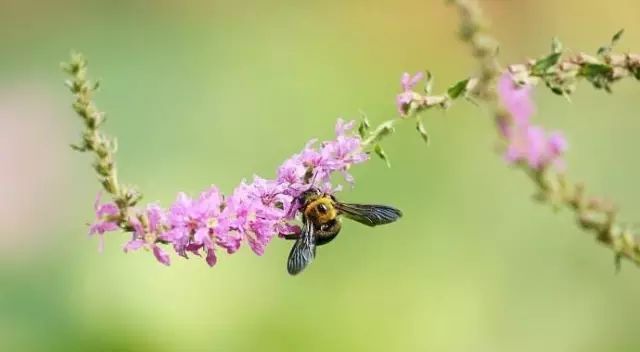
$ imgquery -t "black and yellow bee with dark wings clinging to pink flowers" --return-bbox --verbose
[285,188,402,275]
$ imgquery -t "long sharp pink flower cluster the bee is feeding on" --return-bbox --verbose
[89,119,368,266]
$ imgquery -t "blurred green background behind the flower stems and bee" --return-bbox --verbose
[0,0,640,351]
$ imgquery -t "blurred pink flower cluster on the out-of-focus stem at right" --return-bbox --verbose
[498,73,568,170]
